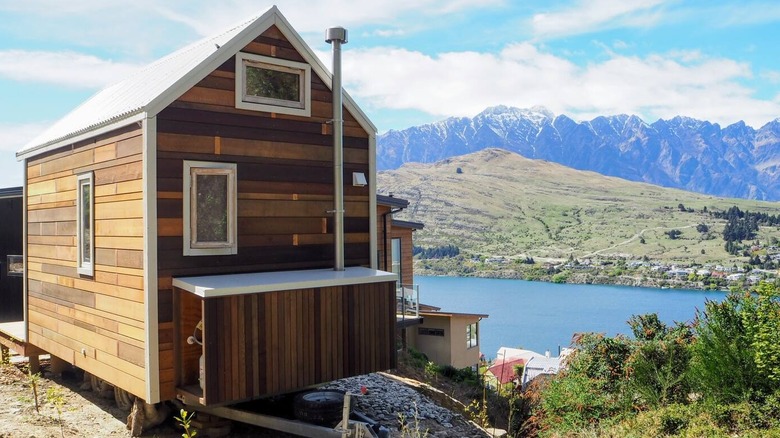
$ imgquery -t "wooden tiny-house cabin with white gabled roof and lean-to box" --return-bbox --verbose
[17,7,396,405]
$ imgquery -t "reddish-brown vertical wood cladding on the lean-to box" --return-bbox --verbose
[176,282,396,404]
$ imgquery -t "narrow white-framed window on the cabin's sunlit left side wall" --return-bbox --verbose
[76,172,95,276]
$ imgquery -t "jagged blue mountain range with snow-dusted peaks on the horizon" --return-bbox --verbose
[377,106,780,201]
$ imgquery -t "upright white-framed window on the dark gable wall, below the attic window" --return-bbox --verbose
[183,161,238,255]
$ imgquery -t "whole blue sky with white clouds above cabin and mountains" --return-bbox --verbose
[0,0,780,187]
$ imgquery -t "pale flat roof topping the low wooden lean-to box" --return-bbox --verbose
[173,266,398,298]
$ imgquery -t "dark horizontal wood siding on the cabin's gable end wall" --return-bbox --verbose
[157,26,378,400]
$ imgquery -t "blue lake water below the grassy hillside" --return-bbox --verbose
[415,276,726,358]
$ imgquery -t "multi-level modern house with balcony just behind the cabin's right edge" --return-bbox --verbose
[377,195,487,368]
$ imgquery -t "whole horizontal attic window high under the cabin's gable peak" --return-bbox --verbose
[236,53,311,117]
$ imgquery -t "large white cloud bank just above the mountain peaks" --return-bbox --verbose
[344,43,780,129]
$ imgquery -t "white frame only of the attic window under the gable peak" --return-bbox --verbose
[235,52,311,117]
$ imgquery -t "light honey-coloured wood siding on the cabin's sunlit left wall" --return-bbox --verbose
[27,124,146,397]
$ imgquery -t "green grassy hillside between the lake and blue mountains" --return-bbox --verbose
[378,149,780,265]
